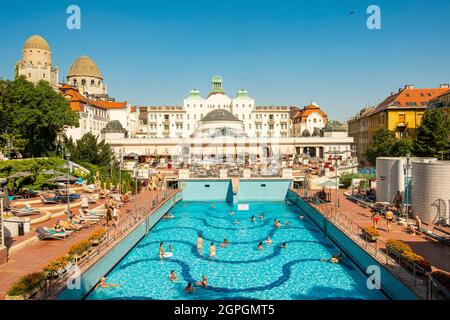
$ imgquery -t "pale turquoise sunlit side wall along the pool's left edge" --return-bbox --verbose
[57,192,182,300]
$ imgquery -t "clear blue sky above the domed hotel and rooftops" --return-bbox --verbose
[0,0,450,120]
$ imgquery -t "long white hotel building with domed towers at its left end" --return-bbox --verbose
[15,35,357,170]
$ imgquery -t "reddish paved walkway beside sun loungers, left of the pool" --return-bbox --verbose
[0,191,174,299]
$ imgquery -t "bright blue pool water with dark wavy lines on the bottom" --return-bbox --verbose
[87,201,386,300]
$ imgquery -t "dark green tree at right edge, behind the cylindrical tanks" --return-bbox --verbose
[414,110,450,159]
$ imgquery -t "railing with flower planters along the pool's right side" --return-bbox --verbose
[299,190,445,300]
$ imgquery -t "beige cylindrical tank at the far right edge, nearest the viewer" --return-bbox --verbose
[412,160,450,225]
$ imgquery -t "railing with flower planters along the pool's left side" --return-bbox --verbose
[34,190,176,300]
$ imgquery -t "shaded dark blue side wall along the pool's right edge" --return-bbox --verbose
[287,190,417,300]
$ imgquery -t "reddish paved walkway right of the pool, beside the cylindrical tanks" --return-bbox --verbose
[310,190,450,272]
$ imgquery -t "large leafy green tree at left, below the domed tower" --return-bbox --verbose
[0,76,78,157]
